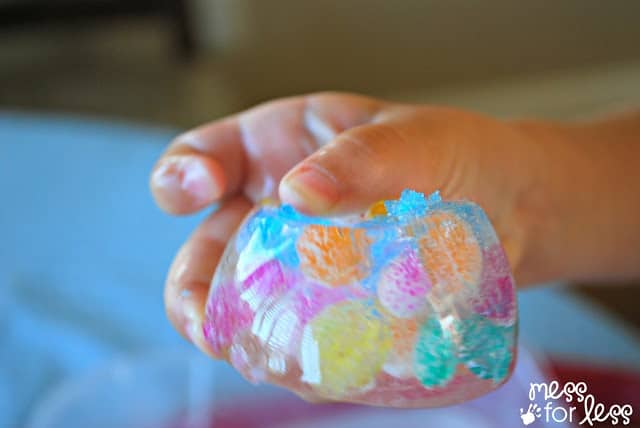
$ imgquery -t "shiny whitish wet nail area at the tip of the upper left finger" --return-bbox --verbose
[153,156,216,202]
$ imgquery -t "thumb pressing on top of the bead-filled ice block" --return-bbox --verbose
[279,111,462,215]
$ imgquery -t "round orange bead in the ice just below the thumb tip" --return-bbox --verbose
[296,225,370,286]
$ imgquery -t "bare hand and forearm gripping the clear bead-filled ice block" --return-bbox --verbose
[151,93,640,362]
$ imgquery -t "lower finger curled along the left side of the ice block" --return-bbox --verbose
[164,196,251,355]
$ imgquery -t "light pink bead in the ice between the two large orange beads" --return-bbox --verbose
[378,248,431,318]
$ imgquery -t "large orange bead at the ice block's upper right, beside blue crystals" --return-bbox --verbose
[419,212,482,293]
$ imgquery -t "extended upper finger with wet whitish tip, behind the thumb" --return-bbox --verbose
[151,93,383,214]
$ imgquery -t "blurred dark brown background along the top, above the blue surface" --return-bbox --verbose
[0,0,640,127]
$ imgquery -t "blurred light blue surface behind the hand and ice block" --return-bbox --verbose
[0,112,640,427]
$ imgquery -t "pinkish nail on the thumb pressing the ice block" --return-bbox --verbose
[280,165,338,214]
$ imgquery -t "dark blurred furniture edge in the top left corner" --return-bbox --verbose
[0,0,195,59]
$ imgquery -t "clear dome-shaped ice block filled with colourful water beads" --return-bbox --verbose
[203,190,517,407]
